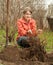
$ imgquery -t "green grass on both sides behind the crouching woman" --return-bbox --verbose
[0,30,53,52]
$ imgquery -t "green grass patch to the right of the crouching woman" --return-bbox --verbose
[39,31,53,52]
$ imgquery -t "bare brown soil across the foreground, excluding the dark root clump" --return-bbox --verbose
[0,46,53,65]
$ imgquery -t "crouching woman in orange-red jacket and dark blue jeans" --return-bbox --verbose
[17,7,42,48]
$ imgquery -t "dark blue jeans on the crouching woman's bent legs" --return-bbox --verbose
[17,36,30,48]
